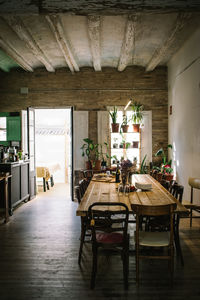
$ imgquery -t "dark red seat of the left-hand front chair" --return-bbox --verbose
[96,232,123,244]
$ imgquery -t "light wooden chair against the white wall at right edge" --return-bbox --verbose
[182,177,200,227]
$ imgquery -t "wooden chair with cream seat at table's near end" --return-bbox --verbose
[133,203,176,283]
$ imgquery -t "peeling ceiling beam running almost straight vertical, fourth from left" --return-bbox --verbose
[87,16,101,71]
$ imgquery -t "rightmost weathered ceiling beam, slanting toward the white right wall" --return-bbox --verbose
[146,13,191,72]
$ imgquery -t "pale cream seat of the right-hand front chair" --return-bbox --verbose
[139,231,170,247]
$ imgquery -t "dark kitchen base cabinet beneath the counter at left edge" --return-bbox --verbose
[0,162,29,215]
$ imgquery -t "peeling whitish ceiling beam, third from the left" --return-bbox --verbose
[46,15,79,73]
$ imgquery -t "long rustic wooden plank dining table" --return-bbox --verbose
[76,174,188,264]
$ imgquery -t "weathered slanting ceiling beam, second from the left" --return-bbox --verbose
[4,16,55,72]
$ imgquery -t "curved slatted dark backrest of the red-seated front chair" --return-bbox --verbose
[88,202,129,241]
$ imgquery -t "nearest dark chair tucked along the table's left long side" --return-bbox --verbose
[75,186,91,265]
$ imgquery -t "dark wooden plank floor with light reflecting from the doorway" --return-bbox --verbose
[0,184,200,300]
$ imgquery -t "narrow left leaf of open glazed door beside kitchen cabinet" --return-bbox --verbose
[27,107,36,199]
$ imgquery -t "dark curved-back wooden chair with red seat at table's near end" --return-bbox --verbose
[88,202,129,289]
